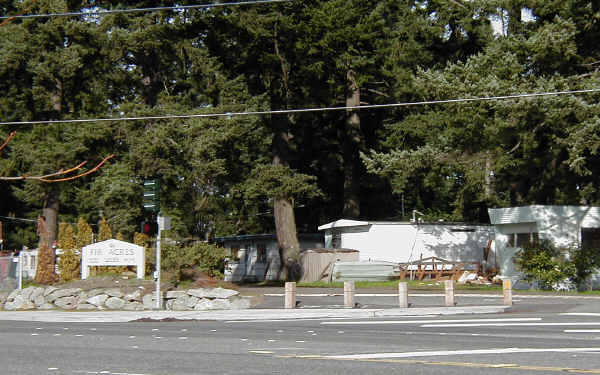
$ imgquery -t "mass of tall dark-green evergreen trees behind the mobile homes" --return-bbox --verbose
[0,0,600,258]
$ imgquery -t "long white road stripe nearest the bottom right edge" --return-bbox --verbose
[322,348,600,359]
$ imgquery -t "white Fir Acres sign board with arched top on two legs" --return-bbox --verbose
[81,240,146,279]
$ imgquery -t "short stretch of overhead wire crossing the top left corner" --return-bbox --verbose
[0,0,293,20]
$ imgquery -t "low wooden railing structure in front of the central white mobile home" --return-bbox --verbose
[400,257,481,280]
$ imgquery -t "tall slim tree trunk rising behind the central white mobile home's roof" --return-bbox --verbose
[342,70,361,219]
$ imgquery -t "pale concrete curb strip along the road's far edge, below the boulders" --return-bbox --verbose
[0,306,510,323]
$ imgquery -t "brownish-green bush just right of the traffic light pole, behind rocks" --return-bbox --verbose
[161,242,225,284]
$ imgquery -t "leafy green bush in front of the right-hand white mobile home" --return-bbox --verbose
[516,240,577,289]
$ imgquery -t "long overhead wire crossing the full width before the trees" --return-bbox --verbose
[0,88,600,125]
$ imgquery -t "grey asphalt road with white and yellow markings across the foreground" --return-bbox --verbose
[0,297,600,375]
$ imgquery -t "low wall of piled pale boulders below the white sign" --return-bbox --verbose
[0,286,250,311]
